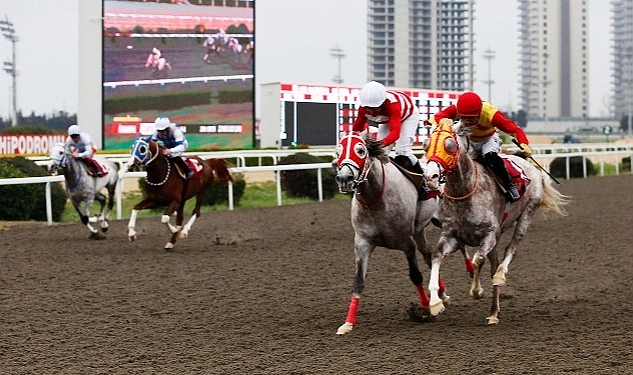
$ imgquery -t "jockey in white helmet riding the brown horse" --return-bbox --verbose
[146,116,193,180]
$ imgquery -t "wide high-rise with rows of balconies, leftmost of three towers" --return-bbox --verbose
[367,0,475,91]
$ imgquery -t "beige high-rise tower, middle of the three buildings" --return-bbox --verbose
[518,0,588,119]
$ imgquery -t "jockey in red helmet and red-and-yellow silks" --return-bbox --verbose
[430,92,532,202]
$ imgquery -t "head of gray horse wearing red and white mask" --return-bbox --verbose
[332,131,384,194]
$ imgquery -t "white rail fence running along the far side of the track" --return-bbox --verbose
[0,144,633,225]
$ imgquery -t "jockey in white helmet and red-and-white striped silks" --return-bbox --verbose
[352,81,423,174]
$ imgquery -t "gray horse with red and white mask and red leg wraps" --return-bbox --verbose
[335,131,449,335]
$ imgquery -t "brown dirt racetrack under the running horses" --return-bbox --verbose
[0,176,633,375]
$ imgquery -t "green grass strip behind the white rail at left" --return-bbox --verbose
[61,181,349,223]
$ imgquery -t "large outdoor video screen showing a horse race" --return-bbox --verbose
[103,0,255,151]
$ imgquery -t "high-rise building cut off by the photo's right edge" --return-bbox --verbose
[611,0,633,125]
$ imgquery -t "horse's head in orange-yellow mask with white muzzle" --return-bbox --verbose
[424,119,464,190]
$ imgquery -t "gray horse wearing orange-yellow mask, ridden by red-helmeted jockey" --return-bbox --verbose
[425,119,569,324]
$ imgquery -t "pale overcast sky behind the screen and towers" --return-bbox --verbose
[0,0,611,118]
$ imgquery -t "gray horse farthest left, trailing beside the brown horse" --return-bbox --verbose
[49,143,119,239]
